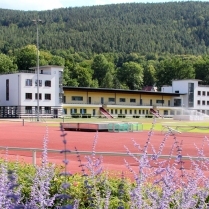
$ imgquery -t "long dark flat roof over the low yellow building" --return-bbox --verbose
[63,86,185,96]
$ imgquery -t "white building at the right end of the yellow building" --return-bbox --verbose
[161,79,209,115]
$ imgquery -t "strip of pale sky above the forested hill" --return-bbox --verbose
[0,0,208,11]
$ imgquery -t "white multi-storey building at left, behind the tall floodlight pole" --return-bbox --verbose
[0,66,63,117]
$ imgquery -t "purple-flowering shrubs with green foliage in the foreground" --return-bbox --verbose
[0,118,209,209]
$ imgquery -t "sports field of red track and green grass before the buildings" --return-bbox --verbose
[0,119,209,179]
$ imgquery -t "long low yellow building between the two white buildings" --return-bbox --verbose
[63,87,181,117]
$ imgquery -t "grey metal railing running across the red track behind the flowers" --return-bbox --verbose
[0,146,209,165]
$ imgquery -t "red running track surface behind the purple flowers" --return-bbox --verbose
[0,122,209,179]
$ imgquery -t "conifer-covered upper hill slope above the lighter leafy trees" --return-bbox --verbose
[0,2,209,54]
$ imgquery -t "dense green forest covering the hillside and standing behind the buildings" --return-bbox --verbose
[0,1,209,89]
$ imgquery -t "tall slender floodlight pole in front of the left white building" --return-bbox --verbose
[33,19,42,121]
